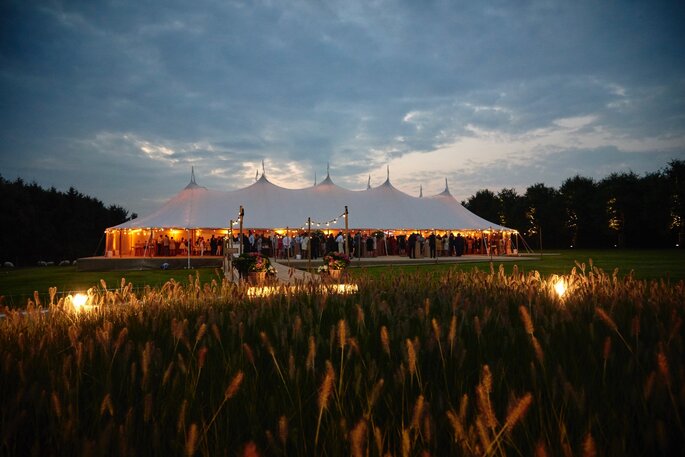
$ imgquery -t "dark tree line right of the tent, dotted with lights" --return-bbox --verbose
[462,160,685,249]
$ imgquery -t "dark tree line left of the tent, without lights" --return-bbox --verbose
[0,176,130,266]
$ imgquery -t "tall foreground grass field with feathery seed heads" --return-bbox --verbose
[0,263,685,457]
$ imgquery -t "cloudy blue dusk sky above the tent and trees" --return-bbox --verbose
[0,0,685,215]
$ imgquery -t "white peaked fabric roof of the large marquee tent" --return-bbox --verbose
[108,174,510,230]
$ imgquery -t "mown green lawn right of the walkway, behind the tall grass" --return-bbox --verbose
[350,249,685,281]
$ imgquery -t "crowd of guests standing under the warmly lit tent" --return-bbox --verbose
[140,230,514,259]
